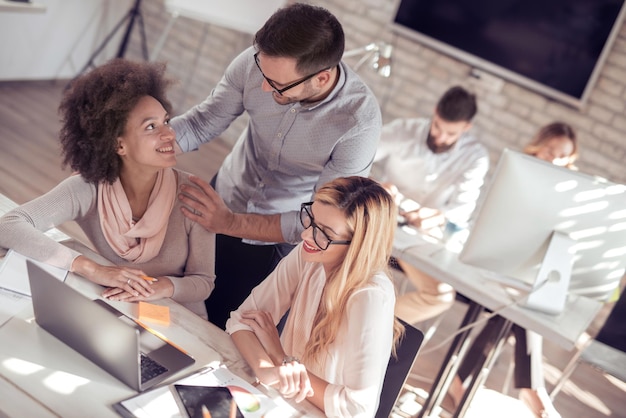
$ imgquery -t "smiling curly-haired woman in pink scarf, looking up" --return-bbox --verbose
[0,59,215,318]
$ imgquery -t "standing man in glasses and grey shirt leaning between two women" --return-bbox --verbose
[172,3,382,328]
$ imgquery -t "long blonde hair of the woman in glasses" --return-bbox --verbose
[304,176,404,360]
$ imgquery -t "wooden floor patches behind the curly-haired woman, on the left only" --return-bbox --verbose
[0,81,230,203]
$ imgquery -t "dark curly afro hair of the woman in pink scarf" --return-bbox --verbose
[59,58,172,184]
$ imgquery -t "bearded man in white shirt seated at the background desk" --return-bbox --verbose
[375,86,489,323]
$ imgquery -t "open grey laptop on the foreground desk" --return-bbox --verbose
[26,260,195,392]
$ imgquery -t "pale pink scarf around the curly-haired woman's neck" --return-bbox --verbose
[98,168,176,263]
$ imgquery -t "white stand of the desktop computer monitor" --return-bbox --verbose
[523,231,575,315]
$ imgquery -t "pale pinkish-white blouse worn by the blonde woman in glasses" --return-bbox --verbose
[226,244,395,417]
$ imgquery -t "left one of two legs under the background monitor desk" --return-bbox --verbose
[418,301,483,418]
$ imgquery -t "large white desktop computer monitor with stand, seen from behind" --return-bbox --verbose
[459,149,626,314]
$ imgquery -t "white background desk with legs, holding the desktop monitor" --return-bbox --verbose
[393,227,602,417]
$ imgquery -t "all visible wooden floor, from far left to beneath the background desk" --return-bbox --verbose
[0,81,626,418]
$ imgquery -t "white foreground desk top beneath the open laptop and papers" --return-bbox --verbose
[0,195,323,417]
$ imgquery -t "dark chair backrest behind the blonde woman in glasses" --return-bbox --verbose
[376,318,424,418]
